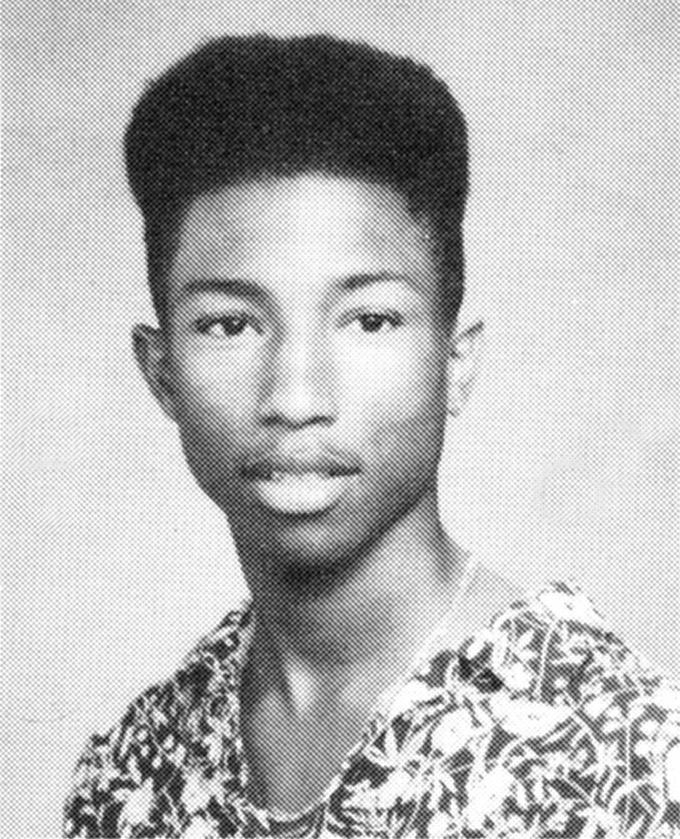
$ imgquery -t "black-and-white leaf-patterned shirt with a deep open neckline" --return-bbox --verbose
[65,583,680,839]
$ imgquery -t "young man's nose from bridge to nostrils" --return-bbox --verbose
[260,324,337,428]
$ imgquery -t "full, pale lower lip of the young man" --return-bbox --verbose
[248,472,356,515]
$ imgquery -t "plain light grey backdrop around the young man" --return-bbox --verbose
[2,0,680,837]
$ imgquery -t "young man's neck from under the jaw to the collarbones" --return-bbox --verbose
[235,492,464,716]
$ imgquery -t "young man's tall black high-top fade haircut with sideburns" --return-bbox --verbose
[125,35,468,323]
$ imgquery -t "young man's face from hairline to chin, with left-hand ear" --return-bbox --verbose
[136,175,478,576]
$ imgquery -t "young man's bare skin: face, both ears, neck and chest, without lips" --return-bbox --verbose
[134,173,482,808]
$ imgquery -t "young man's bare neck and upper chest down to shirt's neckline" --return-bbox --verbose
[240,520,476,814]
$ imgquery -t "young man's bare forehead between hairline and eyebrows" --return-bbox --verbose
[169,174,434,296]
